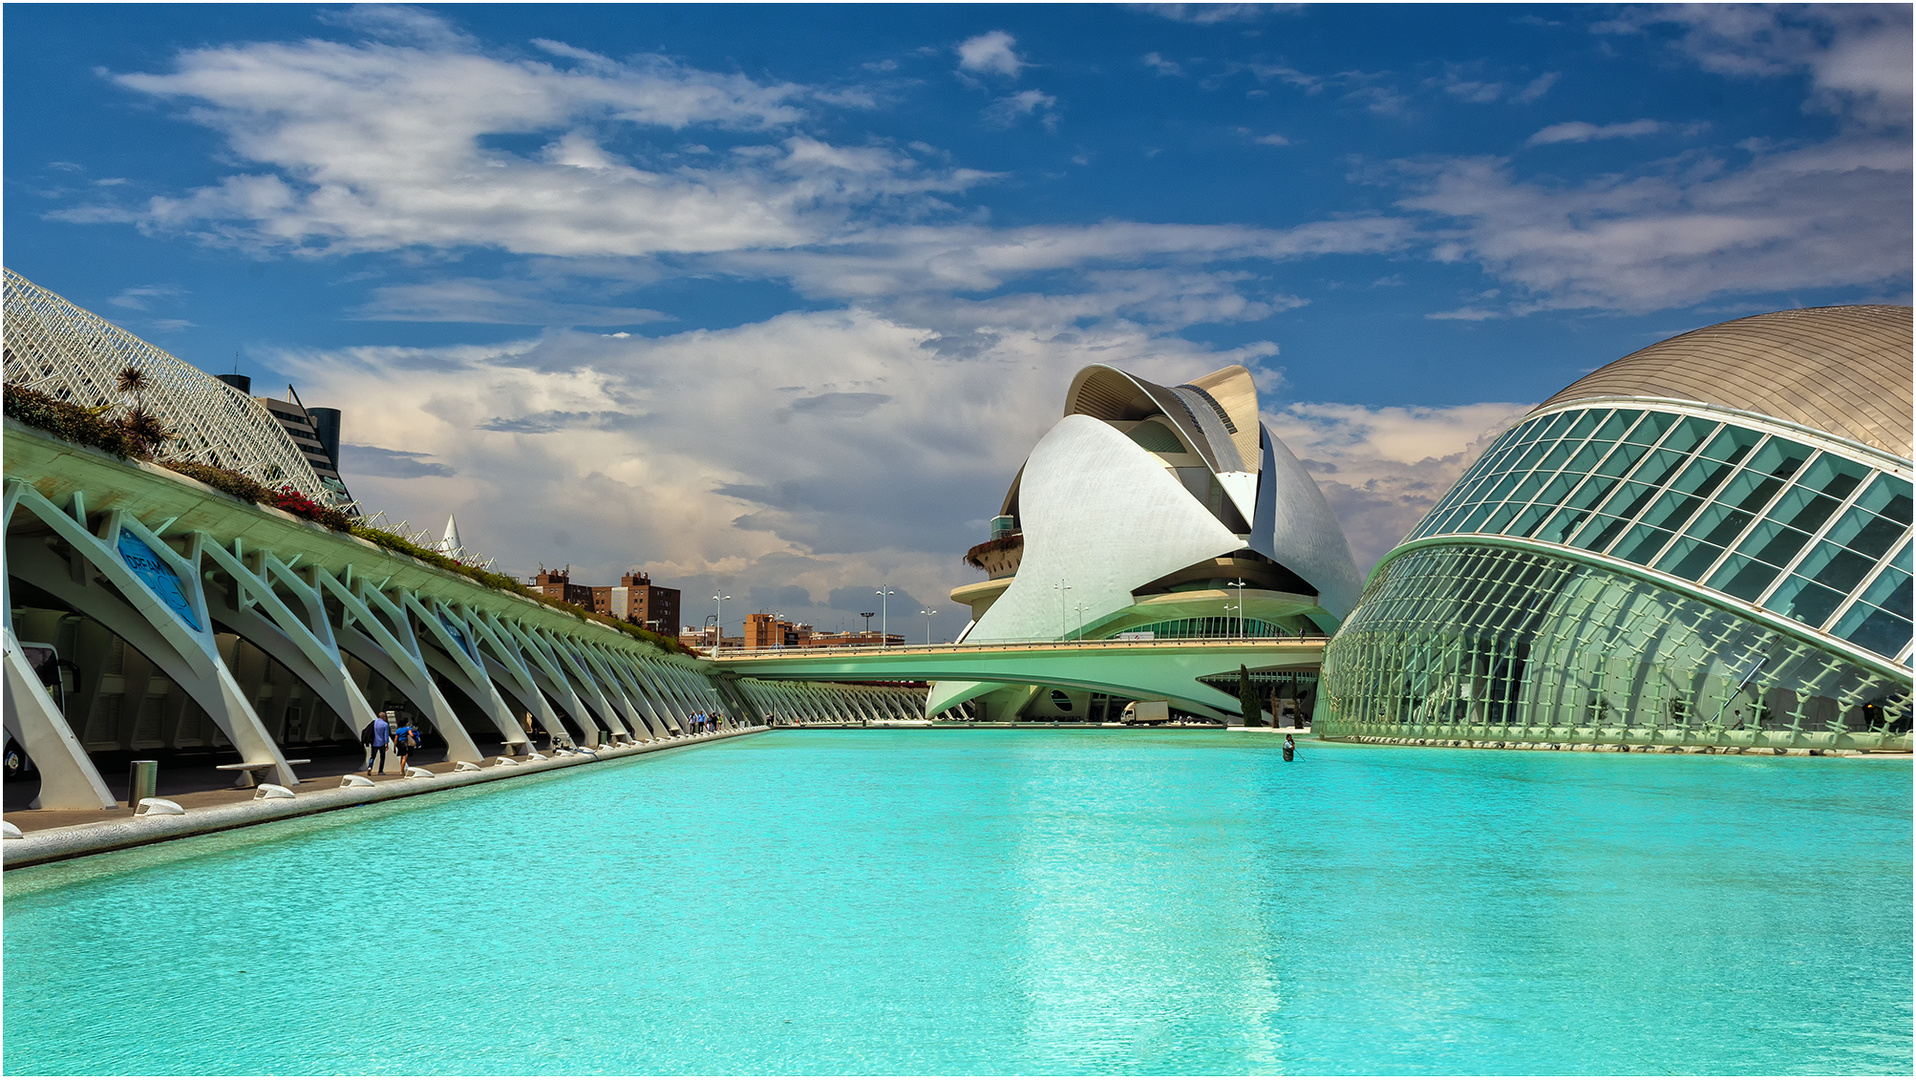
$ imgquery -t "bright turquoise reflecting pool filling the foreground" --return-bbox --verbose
[4,731,1912,1074]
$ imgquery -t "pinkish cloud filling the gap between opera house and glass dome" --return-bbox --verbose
[1265,402,1531,573]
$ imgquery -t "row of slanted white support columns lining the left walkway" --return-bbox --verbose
[4,481,753,810]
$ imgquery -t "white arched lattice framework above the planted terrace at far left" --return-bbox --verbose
[4,270,354,509]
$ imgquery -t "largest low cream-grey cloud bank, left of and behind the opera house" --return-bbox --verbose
[272,308,1270,632]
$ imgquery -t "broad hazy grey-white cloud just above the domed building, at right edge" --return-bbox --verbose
[1401,136,1910,318]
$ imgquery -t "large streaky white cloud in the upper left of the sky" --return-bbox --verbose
[59,17,983,255]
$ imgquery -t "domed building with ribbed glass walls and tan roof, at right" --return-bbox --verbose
[1314,306,1912,751]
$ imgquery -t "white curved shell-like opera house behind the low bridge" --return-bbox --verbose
[927,364,1362,718]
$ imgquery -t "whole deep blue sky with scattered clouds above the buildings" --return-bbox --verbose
[4,4,1910,636]
